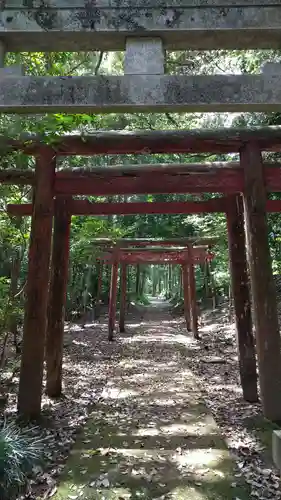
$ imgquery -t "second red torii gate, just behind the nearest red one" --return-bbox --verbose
[8,195,281,412]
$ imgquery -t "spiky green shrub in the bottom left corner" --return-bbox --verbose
[0,423,43,500]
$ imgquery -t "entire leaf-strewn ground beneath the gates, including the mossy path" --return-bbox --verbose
[4,299,281,500]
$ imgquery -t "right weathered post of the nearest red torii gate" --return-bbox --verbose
[240,142,281,420]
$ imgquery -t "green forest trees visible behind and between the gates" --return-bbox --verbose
[0,46,281,498]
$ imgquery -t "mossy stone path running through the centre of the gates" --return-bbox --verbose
[54,300,249,500]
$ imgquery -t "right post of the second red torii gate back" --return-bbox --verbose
[226,195,258,403]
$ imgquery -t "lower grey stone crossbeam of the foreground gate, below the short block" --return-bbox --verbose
[0,74,281,113]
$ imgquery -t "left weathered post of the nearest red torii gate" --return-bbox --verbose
[18,148,56,418]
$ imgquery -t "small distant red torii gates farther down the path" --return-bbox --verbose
[95,244,214,341]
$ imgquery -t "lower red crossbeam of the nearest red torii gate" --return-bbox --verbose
[0,162,281,196]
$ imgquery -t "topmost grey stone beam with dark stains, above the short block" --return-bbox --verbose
[0,4,281,52]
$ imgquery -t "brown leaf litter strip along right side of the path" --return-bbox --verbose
[192,307,281,500]
